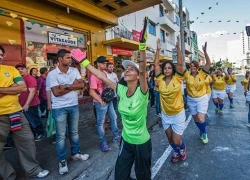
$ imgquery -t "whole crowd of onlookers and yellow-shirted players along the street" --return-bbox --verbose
[0,20,250,180]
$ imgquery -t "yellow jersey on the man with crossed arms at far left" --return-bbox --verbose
[0,65,23,115]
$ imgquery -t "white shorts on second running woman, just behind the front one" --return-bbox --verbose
[187,94,208,115]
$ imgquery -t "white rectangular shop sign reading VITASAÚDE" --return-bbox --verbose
[48,32,78,47]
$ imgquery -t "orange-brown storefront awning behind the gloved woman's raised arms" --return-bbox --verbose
[102,38,139,51]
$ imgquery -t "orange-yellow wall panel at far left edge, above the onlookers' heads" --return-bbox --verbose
[0,16,21,44]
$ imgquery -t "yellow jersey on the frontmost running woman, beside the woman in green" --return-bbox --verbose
[156,73,184,116]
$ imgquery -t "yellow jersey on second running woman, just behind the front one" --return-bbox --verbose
[184,69,208,98]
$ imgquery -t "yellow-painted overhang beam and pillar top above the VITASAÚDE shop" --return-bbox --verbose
[0,0,111,61]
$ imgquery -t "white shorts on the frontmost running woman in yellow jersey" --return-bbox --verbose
[161,109,186,135]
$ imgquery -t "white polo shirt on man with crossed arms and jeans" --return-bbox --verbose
[46,67,82,109]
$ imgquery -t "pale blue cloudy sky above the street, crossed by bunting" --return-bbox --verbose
[174,0,250,59]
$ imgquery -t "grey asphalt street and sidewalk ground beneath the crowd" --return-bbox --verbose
[5,76,250,180]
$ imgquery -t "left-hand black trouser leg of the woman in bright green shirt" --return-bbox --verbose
[115,139,136,180]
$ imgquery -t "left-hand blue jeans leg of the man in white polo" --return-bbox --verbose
[52,108,68,161]
